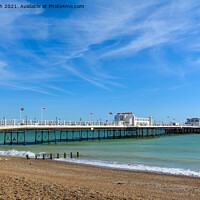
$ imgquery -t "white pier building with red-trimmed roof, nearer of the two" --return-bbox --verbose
[115,112,152,126]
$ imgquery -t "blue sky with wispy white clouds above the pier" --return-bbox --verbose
[0,0,200,122]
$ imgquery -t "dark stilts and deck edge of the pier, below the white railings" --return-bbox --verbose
[0,126,200,145]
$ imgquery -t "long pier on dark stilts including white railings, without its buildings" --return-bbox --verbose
[0,120,200,145]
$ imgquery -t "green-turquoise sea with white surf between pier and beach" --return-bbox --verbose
[0,134,200,177]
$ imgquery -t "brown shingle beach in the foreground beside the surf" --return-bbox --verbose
[0,157,200,200]
